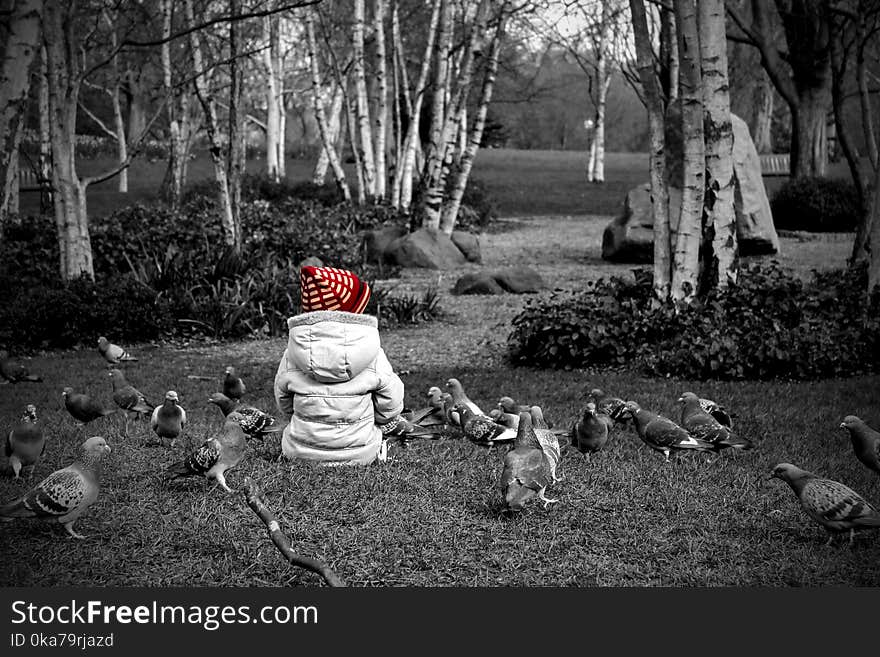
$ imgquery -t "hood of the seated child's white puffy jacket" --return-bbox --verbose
[287,310,380,383]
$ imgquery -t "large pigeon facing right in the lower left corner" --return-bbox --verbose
[0,436,110,539]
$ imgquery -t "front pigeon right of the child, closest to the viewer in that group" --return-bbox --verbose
[499,412,559,511]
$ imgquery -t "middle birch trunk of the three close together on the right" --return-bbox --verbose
[671,0,706,303]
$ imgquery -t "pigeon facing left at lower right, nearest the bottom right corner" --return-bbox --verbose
[770,463,880,545]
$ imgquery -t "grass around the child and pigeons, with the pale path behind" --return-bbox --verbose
[0,216,880,586]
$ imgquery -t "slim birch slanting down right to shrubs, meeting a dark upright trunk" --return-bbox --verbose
[183,0,241,250]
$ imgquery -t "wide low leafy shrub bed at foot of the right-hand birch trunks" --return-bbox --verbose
[508,264,880,380]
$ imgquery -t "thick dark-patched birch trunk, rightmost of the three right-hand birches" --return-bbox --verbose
[698,0,737,288]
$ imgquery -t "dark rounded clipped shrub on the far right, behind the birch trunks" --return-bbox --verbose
[770,177,862,233]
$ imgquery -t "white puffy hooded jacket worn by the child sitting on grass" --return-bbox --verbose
[275,310,403,464]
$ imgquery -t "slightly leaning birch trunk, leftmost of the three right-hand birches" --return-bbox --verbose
[629,0,672,301]
